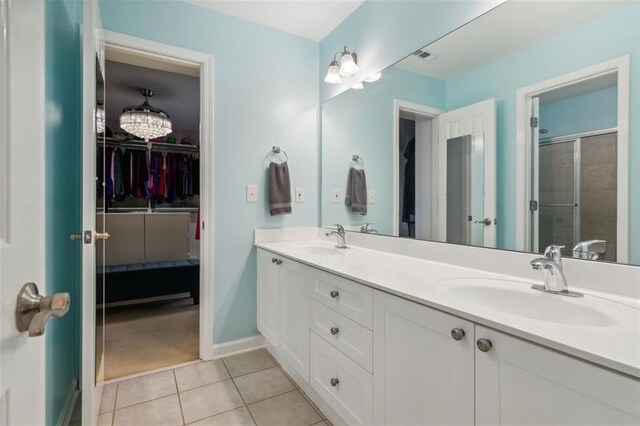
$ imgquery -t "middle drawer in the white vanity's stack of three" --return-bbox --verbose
[309,300,373,373]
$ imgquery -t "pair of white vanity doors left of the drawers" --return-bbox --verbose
[258,250,311,381]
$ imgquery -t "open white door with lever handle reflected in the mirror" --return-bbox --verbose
[436,99,496,247]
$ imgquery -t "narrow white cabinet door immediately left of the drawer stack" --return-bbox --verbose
[278,258,311,382]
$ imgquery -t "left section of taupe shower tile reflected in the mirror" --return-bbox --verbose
[538,142,575,255]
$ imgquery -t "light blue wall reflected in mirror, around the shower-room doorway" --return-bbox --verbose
[447,4,640,263]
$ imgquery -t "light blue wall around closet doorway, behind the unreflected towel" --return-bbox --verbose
[100,0,320,343]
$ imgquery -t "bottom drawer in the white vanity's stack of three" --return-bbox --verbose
[310,331,373,425]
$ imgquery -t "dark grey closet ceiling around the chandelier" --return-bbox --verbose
[105,60,200,137]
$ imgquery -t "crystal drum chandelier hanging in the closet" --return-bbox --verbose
[120,89,171,142]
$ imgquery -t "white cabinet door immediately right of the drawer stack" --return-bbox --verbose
[373,291,474,425]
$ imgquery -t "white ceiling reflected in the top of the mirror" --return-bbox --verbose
[396,0,634,80]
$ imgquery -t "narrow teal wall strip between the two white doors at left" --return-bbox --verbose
[44,0,82,425]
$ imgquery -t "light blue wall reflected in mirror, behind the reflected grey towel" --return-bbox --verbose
[322,67,445,234]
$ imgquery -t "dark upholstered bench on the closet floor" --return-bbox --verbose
[96,259,200,305]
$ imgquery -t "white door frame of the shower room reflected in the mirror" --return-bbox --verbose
[515,55,630,263]
